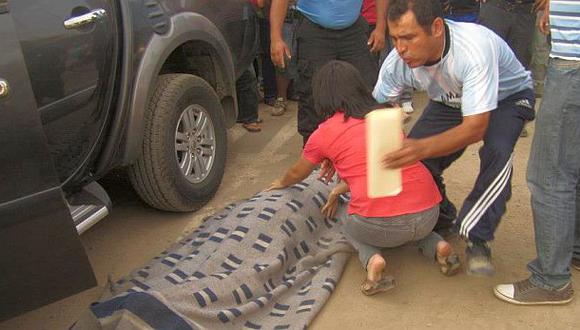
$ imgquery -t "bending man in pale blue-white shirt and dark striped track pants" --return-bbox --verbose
[373,0,535,275]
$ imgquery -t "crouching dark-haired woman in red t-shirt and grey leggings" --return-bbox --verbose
[268,61,460,295]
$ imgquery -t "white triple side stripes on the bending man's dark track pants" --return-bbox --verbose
[459,153,514,238]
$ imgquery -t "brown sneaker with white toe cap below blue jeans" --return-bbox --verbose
[493,279,574,305]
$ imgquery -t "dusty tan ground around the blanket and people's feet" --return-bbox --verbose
[0,95,580,329]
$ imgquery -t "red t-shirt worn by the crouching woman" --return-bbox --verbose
[303,112,441,217]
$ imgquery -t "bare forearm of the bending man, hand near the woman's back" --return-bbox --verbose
[383,112,490,168]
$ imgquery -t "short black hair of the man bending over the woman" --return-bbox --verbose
[387,0,443,34]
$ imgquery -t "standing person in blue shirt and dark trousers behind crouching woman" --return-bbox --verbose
[270,0,387,143]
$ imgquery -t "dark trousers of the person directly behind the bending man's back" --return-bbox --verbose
[479,0,536,69]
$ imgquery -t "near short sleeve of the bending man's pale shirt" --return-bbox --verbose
[461,41,499,116]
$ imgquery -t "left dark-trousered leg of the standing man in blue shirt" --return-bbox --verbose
[294,17,336,144]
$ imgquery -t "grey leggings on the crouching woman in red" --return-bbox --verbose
[343,205,443,269]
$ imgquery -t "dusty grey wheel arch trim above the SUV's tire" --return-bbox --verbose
[121,13,237,165]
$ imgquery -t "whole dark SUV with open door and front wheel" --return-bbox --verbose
[0,0,257,319]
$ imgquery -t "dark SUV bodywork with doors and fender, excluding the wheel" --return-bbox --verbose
[0,0,258,319]
